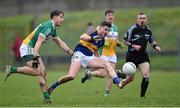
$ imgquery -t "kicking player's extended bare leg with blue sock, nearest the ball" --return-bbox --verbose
[88,57,121,87]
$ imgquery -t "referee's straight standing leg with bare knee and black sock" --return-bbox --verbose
[139,62,149,97]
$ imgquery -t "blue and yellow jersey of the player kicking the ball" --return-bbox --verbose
[74,31,104,56]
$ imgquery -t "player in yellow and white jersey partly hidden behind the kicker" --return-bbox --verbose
[81,10,123,96]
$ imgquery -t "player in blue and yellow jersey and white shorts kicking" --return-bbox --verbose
[48,21,121,94]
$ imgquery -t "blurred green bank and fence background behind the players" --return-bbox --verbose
[0,0,180,71]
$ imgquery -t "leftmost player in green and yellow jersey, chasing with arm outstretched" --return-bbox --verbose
[4,10,73,103]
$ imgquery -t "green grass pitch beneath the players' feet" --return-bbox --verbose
[0,69,180,107]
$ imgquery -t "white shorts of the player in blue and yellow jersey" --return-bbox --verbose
[71,51,95,68]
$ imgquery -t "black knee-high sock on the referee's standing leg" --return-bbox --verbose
[140,78,149,97]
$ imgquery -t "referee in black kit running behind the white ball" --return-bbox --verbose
[124,13,161,97]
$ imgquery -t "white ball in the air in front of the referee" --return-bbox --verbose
[122,62,136,74]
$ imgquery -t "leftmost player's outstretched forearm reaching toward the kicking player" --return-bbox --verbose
[53,37,73,55]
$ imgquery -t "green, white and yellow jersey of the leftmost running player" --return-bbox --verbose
[23,20,57,48]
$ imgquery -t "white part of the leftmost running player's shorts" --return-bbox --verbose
[20,44,34,57]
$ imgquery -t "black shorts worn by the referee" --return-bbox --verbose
[126,52,150,67]
